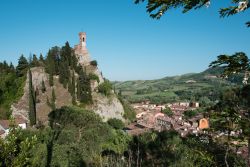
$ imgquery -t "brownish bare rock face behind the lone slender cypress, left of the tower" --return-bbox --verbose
[11,67,72,124]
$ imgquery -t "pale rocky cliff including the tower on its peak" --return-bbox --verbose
[11,33,124,124]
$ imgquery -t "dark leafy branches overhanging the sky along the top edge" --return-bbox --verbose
[134,0,250,27]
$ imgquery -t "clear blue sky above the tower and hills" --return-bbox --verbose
[0,0,250,80]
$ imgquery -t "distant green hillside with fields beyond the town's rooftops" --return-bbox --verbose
[113,68,236,103]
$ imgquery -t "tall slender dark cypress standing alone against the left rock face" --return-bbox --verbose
[29,69,36,126]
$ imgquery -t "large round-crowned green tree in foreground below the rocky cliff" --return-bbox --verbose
[47,107,112,166]
